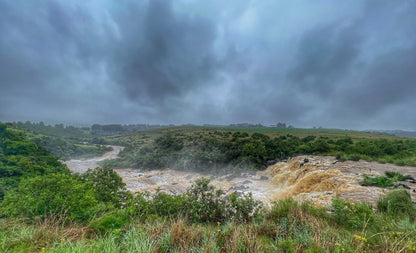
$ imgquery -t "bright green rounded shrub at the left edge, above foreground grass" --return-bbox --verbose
[1,174,98,220]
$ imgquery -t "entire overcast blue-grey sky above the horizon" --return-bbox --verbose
[0,0,416,130]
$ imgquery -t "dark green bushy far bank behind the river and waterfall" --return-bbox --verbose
[104,127,416,170]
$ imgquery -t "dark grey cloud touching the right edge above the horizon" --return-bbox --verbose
[341,47,416,116]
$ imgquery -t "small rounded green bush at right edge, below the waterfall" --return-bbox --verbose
[377,190,416,221]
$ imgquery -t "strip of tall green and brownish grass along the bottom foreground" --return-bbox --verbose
[0,196,416,252]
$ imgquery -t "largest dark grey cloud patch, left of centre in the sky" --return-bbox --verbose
[110,0,217,106]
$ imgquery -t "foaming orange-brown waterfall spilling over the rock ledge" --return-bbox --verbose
[269,156,416,206]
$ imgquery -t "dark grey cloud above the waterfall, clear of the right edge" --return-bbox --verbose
[288,23,362,98]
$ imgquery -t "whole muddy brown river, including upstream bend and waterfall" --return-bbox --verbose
[65,146,416,206]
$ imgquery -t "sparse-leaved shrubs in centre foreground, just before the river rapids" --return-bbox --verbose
[126,178,263,223]
